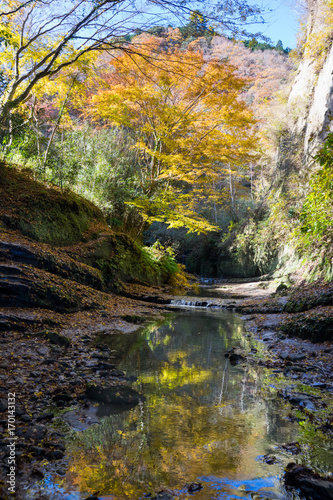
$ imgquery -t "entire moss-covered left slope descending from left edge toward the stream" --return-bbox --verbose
[0,163,181,288]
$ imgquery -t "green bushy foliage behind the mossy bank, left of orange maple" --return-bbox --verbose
[2,124,141,229]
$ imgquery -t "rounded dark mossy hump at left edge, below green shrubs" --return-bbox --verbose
[0,163,107,245]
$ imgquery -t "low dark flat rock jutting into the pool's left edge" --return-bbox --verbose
[86,385,142,406]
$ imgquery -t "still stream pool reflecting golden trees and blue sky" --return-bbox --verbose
[39,308,332,500]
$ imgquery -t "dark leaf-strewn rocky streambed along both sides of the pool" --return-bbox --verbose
[0,235,333,499]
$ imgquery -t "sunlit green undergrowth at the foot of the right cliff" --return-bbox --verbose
[231,133,333,281]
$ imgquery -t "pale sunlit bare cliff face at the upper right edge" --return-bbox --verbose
[288,0,333,163]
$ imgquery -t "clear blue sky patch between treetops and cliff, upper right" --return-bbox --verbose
[247,0,302,49]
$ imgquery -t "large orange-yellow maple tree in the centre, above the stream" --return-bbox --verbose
[86,37,255,232]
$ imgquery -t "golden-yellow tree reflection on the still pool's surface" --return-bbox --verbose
[64,314,288,500]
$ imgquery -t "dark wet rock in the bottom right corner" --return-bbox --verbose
[284,463,333,500]
